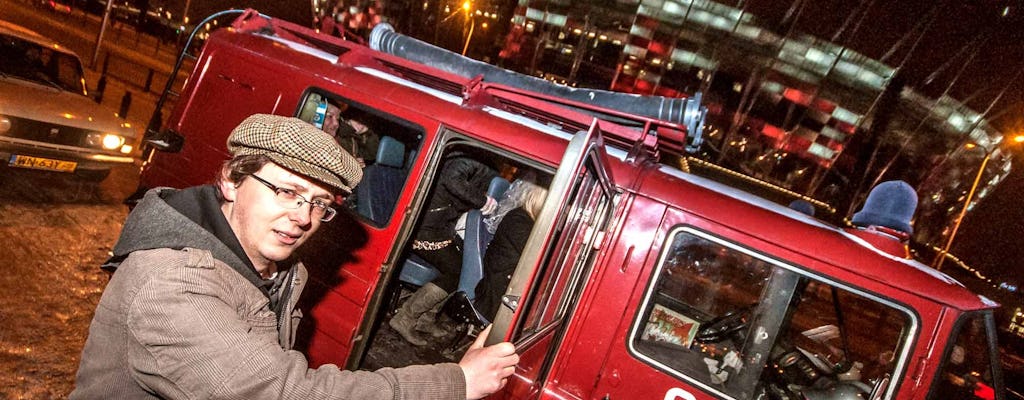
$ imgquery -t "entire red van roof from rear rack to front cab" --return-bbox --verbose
[216,11,997,310]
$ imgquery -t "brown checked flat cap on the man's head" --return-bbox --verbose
[227,114,362,194]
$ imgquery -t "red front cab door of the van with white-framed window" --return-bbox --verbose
[589,221,920,400]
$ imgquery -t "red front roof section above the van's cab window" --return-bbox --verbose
[636,166,998,310]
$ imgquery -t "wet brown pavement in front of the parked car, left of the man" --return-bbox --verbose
[0,166,138,399]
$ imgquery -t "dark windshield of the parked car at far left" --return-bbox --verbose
[0,35,85,94]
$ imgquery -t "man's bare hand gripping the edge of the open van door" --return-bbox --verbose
[459,326,519,400]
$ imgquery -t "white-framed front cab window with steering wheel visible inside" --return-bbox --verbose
[630,228,912,399]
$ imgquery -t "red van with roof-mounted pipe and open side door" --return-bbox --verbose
[140,10,1005,400]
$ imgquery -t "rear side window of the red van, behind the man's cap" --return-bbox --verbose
[296,90,424,226]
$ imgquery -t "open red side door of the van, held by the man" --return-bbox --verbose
[487,120,615,399]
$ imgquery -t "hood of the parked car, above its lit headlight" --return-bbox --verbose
[0,77,135,138]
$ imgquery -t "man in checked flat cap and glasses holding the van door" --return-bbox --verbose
[71,115,518,399]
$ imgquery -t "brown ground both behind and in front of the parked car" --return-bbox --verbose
[0,0,183,400]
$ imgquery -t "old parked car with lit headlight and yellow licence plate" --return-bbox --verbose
[0,20,135,181]
